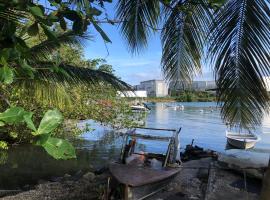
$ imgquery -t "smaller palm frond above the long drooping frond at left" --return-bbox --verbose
[29,31,92,61]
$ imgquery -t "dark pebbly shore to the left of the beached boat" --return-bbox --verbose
[0,172,108,200]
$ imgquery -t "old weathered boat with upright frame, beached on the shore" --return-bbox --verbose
[109,128,181,200]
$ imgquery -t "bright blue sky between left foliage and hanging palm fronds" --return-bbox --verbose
[84,4,213,85]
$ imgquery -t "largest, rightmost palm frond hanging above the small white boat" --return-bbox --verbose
[208,0,270,128]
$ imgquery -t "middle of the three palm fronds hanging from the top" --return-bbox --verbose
[161,3,210,83]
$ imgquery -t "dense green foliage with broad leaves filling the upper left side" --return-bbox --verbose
[0,0,130,159]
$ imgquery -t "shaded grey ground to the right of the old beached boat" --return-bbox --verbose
[150,158,261,200]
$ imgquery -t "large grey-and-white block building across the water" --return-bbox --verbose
[134,80,168,97]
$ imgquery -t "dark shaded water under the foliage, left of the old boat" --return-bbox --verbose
[0,127,121,189]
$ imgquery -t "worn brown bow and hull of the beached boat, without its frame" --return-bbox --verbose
[109,163,181,200]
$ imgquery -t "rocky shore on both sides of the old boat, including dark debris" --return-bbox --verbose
[0,145,265,200]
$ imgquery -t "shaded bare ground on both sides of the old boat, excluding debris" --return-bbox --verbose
[1,158,261,200]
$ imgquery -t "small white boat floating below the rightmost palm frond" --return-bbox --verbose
[226,131,260,149]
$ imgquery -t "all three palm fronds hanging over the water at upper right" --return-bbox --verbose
[117,0,270,128]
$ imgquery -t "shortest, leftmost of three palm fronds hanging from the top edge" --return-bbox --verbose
[117,0,160,53]
